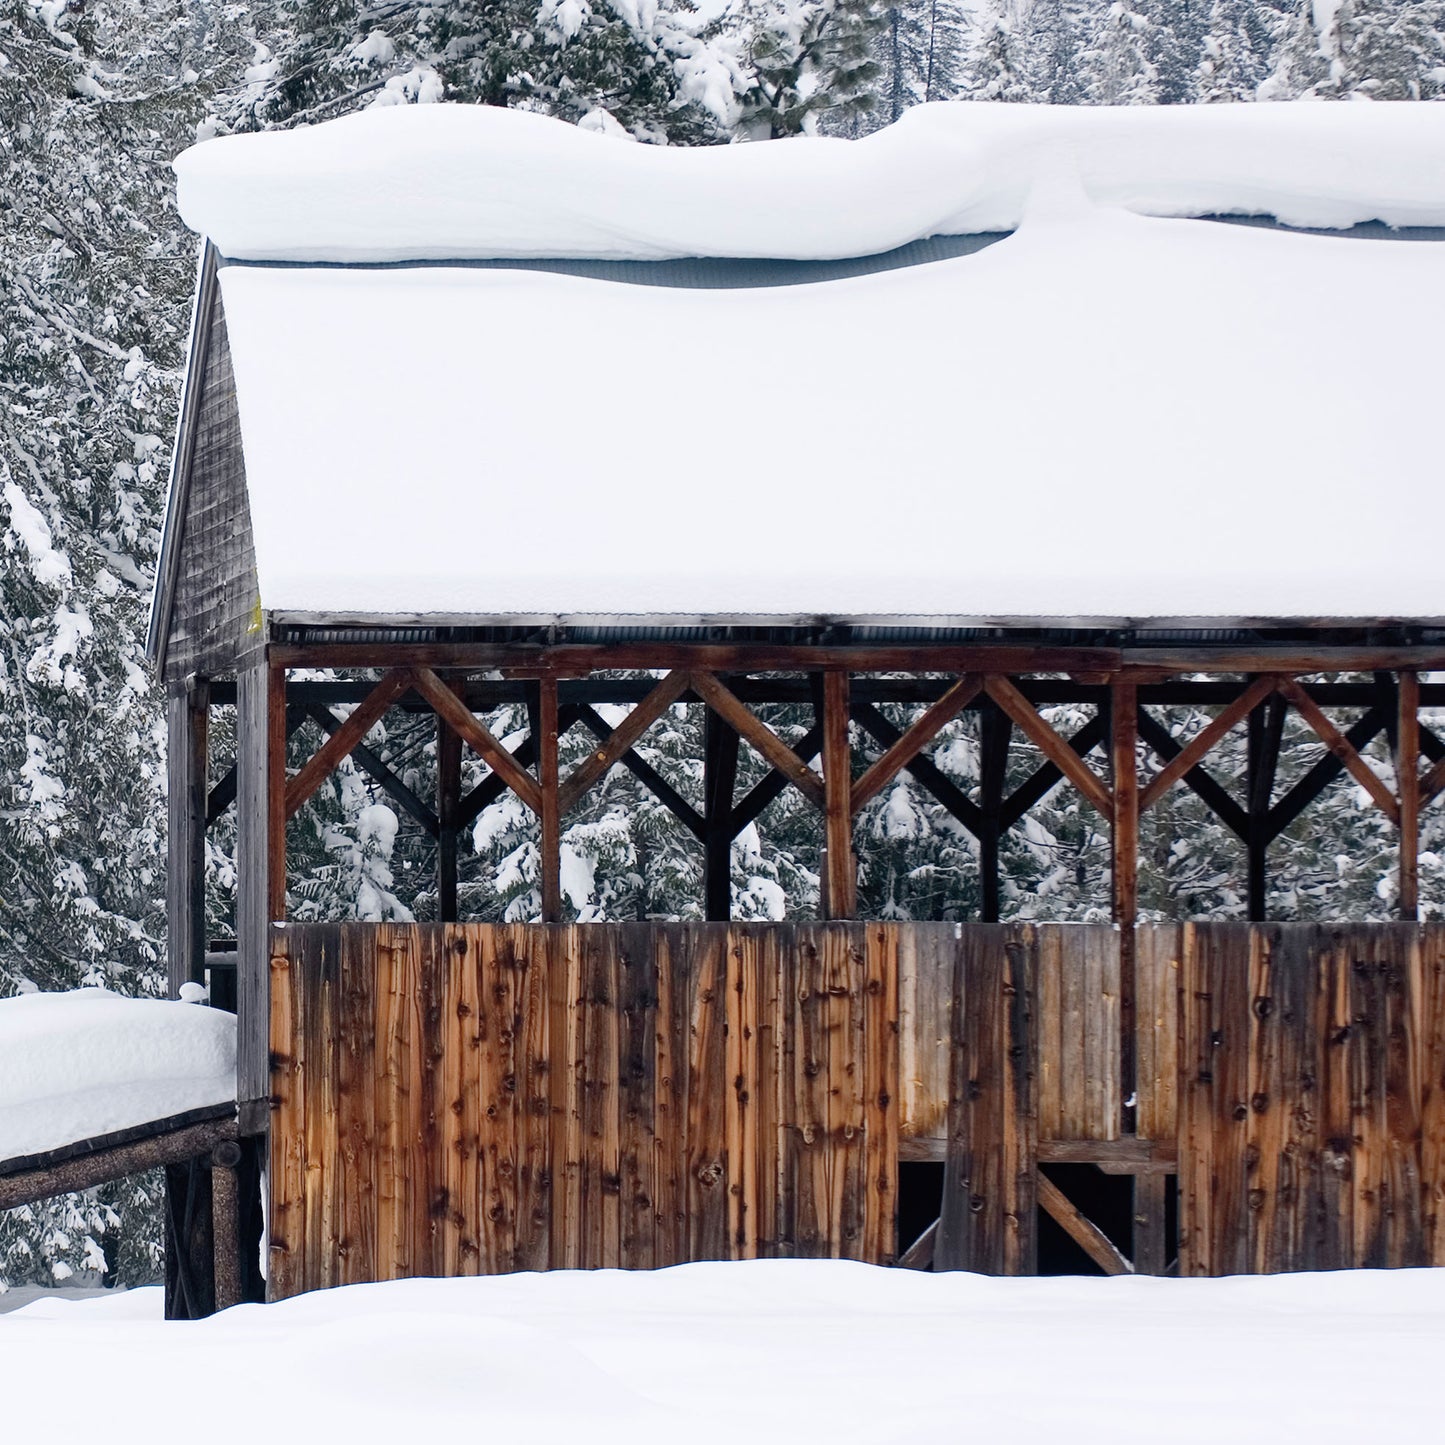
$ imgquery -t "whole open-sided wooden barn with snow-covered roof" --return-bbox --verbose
[150,105,1445,1299]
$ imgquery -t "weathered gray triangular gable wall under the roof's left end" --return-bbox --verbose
[166,288,262,681]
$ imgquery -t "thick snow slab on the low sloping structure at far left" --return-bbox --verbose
[0,988,236,1160]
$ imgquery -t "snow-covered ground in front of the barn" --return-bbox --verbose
[0,1261,1445,1445]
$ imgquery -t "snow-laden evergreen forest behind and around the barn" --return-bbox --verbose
[0,0,1445,1287]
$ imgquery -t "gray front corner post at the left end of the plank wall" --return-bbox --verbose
[236,662,286,1134]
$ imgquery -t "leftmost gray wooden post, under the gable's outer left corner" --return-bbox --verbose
[166,679,211,998]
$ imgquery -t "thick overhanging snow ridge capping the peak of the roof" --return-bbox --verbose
[176,101,1445,260]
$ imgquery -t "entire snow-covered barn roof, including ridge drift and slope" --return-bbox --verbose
[164,104,1445,623]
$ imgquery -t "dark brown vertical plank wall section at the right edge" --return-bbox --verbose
[1179,923,1445,1274]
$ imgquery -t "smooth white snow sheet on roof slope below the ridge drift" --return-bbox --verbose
[221,195,1445,618]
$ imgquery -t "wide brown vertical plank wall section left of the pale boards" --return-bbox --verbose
[270,923,899,1299]
